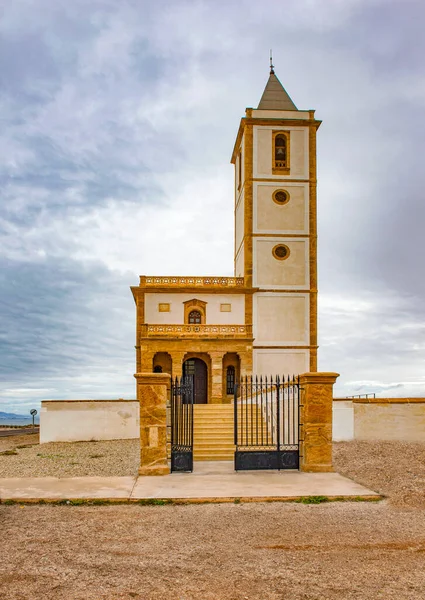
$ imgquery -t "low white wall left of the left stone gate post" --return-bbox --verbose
[40,399,140,444]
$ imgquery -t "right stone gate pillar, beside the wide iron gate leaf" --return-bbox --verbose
[300,373,339,473]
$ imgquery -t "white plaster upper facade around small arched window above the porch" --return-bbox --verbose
[145,292,245,325]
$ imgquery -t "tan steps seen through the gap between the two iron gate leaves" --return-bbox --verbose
[193,404,235,460]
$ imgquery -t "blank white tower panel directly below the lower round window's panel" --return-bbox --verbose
[253,292,310,346]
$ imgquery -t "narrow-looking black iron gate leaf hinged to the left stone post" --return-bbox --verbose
[171,376,194,472]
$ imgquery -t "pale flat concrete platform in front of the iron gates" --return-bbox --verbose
[0,461,380,502]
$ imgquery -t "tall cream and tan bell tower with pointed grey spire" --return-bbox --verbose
[231,65,321,375]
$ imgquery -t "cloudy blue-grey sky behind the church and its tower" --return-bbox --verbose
[0,0,425,413]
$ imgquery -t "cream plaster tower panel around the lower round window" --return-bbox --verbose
[253,237,310,289]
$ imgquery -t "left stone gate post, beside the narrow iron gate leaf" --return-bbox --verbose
[134,373,171,475]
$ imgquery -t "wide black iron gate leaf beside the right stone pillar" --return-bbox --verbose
[234,376,300,471]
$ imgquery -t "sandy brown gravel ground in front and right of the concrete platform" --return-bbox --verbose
[0,442,425,600]
